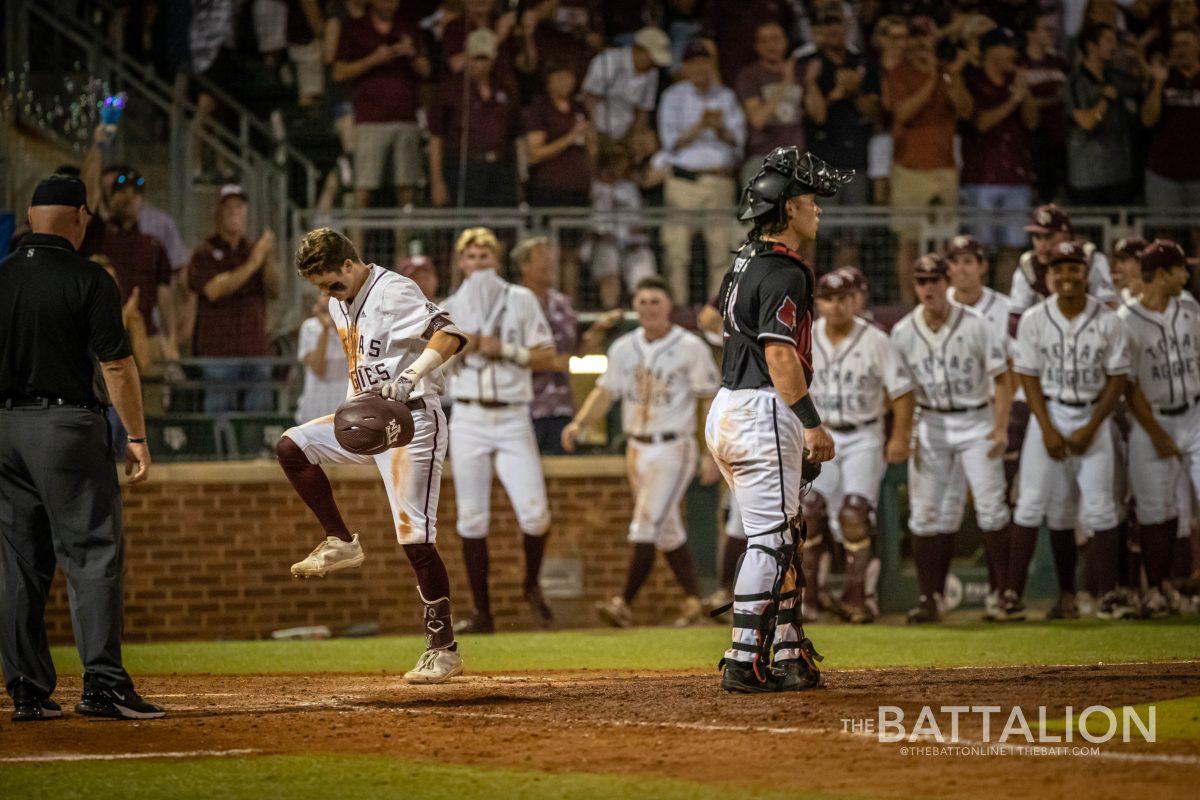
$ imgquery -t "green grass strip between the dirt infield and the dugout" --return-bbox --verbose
[54,619,1200,675]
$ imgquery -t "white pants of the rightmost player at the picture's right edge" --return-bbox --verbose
[1129,405,1200,528]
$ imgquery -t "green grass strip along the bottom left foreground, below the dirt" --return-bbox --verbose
[0,756,902,800]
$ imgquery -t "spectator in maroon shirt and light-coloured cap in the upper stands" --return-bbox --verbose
[430,28,517,207]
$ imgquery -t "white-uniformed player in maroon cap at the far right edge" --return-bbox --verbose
[1117,240,1200,616]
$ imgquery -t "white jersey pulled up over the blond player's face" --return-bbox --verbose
[442,270,554,403]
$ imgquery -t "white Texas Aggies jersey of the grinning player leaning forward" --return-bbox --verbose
[1013,295,1129,404]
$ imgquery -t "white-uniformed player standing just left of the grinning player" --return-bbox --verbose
[888,253,1012,622]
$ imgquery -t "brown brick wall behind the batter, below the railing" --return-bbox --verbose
[47,457,700,643]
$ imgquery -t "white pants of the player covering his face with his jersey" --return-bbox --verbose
[450,401,550,539]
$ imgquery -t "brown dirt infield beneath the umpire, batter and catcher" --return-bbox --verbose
[0,662,1200,800]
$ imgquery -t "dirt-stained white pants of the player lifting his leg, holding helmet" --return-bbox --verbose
[283,396,448,545]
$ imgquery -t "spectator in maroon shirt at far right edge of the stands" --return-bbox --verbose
[1141,28,1200,212]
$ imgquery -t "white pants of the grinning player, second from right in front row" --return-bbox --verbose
[1013,401,1118,531]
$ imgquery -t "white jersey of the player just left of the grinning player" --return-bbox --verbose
[892,306,1008,411]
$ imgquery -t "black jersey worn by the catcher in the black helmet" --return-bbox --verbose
[718,241,815,389]
